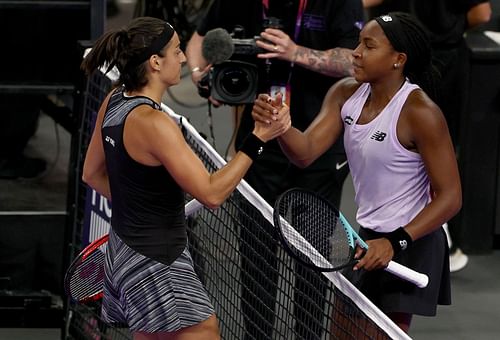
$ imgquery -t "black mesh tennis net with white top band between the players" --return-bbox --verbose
[66,67,409,340]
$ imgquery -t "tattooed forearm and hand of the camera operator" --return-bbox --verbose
[257,28,353,77]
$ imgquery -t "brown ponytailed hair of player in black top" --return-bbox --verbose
[81,17,174,91]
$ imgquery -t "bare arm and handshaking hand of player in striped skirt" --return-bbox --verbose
[124,107,290,208]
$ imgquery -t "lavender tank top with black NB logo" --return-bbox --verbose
[341,81,430,232]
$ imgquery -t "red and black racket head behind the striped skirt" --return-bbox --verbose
[64,235,109,303]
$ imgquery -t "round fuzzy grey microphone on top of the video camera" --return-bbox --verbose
[201,28,234,65]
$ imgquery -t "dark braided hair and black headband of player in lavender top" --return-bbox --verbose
[374,12,440,100]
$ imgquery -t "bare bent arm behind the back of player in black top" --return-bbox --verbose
[82,93,111,200]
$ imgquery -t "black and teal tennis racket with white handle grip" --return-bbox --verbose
[273,189,429,288]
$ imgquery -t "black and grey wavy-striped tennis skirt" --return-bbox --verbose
[102,230,214,333]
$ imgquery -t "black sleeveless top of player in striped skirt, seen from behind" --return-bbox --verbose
[101,87,187,265]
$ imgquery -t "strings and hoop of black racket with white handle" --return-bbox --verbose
[279,192,353,270]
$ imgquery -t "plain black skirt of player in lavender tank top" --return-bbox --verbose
[344,227,451,316]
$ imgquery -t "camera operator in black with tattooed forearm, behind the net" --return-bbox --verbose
[186,0,363,339]
